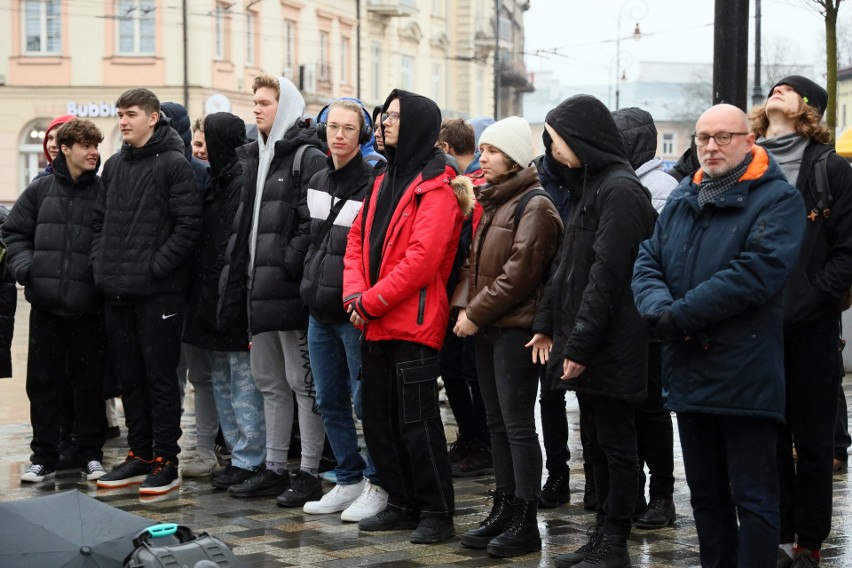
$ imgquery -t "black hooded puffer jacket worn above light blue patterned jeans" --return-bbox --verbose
[183,112,248,351]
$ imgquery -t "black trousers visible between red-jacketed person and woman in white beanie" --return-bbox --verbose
[438,328,491,445]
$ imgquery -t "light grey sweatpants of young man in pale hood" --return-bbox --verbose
[250,331,325,470]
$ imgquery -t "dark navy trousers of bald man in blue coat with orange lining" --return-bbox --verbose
[677,413,781,568]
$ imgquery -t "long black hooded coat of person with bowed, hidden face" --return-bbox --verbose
[533,95,655,401]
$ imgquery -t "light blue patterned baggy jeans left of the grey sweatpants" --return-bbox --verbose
[204,349,266,469]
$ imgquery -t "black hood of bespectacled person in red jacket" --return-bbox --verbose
[382,89,445,179]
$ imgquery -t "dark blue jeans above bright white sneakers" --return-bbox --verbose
[308,316,372,485]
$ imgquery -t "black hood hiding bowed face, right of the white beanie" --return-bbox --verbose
[545,95,630,175]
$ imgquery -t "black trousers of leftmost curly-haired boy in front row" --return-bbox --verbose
[27,306,107,468]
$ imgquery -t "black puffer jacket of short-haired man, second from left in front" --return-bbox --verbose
[90,120,203,302]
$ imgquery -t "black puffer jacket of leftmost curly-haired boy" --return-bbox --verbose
[3,154,103,315]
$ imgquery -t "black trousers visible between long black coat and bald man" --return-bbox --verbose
[636,342,674,499]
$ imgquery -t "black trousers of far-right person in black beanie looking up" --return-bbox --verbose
[778,319,840,550]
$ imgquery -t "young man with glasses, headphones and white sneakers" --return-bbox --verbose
[300,99,388,522]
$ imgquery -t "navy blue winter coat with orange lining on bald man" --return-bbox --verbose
[632,146,805,421]
